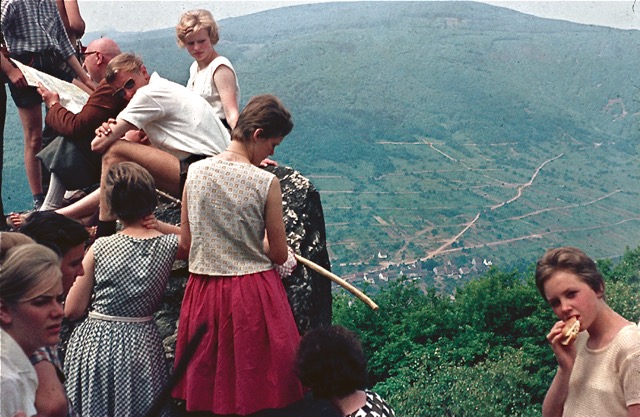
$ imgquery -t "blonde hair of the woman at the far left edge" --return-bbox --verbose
[0,243,62,305]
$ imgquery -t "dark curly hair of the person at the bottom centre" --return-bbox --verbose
[296,326,367,399]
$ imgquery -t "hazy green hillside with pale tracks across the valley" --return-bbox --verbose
[5,1,640,282]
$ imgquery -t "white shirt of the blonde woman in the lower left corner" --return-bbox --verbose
[0,329,38,417]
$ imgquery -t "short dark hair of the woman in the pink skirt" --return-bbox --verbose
[231,94,293,142]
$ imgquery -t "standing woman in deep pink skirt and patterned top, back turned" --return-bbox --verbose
[173,95,302,415]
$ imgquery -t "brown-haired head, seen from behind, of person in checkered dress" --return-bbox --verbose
[105,162,158,222]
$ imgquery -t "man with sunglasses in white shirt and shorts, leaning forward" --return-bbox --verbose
[91,53,230,236]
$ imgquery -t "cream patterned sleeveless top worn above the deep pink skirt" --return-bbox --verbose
[185,158,275,276]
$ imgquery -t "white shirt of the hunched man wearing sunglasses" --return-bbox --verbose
[118,72,230,160]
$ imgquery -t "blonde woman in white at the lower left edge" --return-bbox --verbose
[0,243,63,416]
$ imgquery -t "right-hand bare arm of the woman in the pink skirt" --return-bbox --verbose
[264,178,287,265]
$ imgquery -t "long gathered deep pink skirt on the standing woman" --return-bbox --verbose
[172,270,302,415]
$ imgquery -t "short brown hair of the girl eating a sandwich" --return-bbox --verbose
[536,246,604,301]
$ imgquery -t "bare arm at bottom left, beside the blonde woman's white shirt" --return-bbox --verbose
[34,361,67,417]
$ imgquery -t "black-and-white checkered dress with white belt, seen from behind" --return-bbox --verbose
[64,234,178,417]
